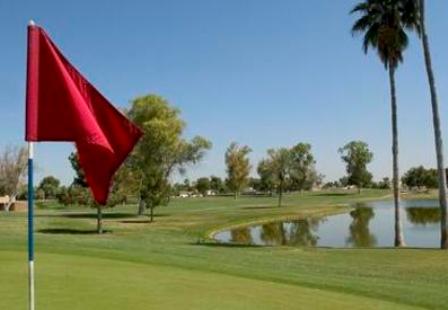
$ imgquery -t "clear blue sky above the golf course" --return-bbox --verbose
[0,0,448,184]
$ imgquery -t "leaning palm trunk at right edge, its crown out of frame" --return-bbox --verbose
[420,0,448,249]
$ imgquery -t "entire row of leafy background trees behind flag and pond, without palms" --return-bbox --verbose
[0,95,444,232]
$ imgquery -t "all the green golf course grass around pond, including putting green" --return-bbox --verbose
[0,191,448,310]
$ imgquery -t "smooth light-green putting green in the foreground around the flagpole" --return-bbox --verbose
[0,252,420,310]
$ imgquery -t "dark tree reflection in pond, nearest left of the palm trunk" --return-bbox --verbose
[346,206,377,248]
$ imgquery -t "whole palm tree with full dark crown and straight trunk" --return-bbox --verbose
[350,0,417,247]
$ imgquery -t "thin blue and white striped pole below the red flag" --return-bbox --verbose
[28,141,35,310]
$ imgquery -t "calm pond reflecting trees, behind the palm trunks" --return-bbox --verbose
[214,200,440,248]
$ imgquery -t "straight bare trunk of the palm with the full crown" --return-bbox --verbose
[389,65,405,247]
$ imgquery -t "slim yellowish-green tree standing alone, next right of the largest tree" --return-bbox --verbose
[225,142,252,199]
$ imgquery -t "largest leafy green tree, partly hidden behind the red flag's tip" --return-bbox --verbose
[127,95,211,221]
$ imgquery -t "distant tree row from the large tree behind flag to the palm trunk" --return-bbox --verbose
[179,141,382,206]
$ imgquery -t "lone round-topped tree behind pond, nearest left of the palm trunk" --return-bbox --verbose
[339,141,373,193]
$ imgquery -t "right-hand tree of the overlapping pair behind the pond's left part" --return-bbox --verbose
[290,143,318,192]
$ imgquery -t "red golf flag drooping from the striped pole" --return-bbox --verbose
[26,26,142,204]
